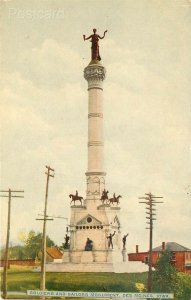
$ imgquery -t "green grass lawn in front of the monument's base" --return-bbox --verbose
[0,267,147,299]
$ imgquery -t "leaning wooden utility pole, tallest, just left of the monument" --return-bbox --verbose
[37,166,54,299]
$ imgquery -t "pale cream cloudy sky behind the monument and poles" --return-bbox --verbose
[0,0,191,252]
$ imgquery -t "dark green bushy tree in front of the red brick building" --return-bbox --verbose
[153,251,180,294]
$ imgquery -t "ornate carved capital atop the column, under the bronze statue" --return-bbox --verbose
[84,64,106,90]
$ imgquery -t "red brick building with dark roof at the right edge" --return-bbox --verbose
[128,242,191,274]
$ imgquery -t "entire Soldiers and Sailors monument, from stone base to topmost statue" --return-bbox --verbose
[46,29,127,272]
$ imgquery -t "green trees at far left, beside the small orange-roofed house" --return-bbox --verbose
[1,230,55,259]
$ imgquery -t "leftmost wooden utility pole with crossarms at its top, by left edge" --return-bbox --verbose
[0,189,24,299]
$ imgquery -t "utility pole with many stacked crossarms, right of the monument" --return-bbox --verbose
[139,193,163,292]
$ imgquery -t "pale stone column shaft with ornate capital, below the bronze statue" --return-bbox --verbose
[84,61,106,199]
